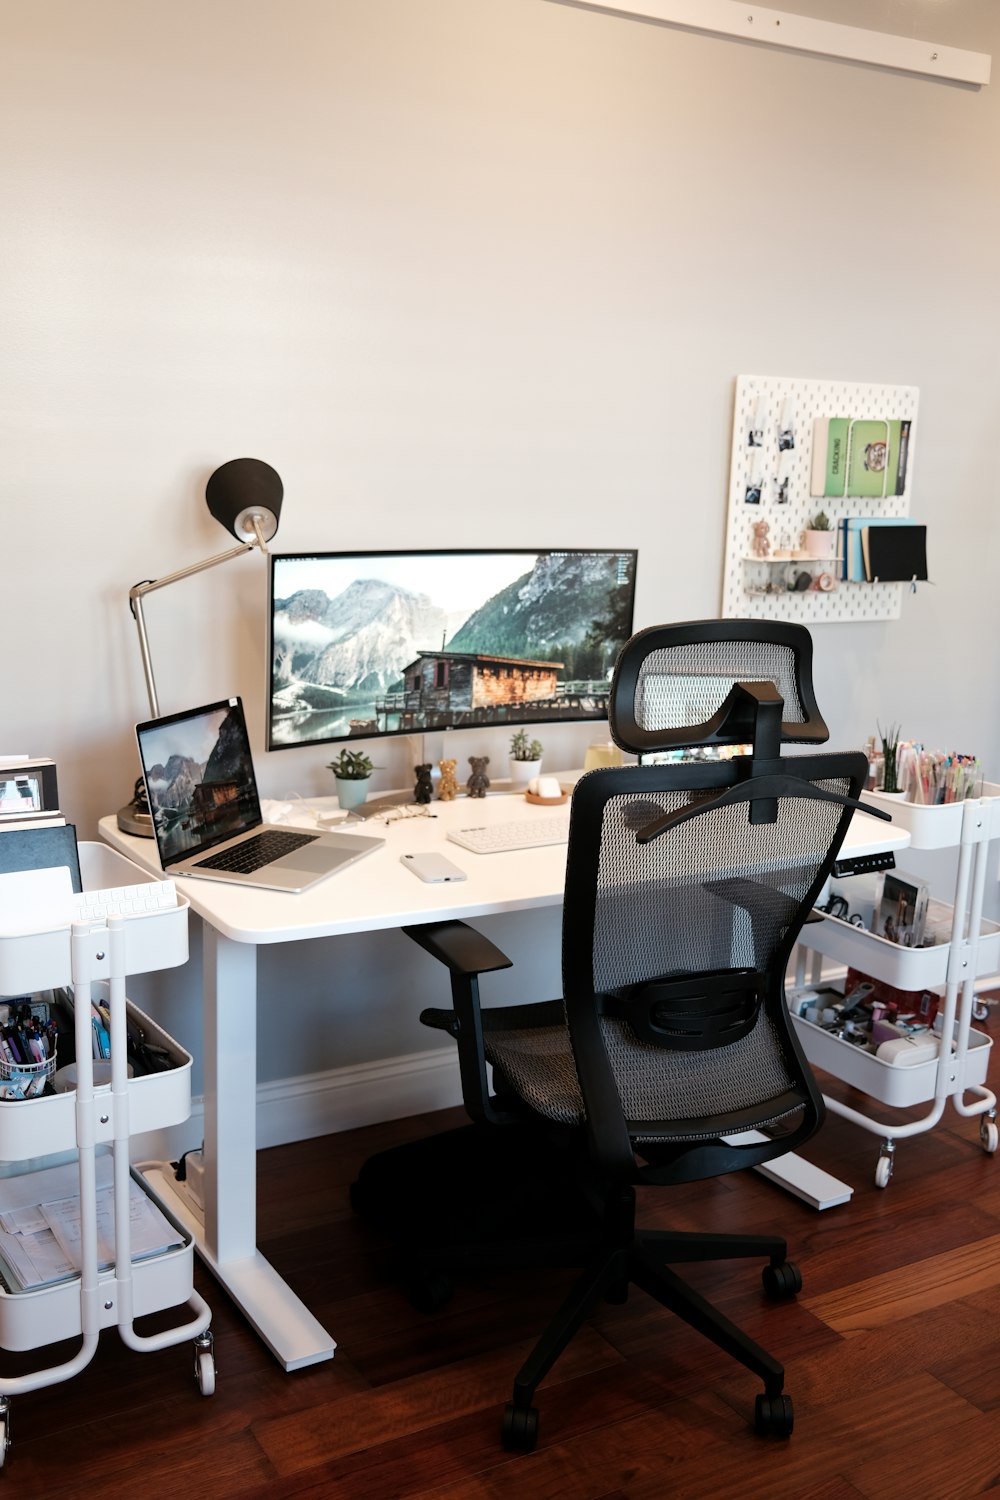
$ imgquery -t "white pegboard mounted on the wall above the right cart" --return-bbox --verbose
[721,375,919,626]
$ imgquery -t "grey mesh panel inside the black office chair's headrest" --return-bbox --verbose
[634,641,807,731]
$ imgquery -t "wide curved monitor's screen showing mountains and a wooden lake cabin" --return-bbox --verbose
[267,548,636,750]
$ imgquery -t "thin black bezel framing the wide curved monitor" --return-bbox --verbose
[264,546,639,752]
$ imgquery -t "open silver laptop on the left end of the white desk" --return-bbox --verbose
[135,698,385,891]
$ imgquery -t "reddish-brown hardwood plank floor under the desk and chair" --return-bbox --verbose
[0,1011,1000,1500]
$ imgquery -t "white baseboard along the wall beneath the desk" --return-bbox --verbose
[132,1047,462,1161]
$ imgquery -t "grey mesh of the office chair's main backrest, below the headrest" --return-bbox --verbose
[564,756,856,1140]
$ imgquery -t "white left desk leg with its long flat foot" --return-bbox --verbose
[156,923,336,1370]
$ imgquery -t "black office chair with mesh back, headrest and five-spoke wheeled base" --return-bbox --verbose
[357,621,868,1451]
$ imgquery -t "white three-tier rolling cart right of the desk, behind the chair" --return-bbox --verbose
[792,783,1000,1188]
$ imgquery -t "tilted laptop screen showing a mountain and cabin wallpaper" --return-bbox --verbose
[135,698,261,869]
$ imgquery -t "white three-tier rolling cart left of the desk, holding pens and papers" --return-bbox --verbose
[0,845,214,1466]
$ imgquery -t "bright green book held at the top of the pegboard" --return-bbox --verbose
[810,417,912,500]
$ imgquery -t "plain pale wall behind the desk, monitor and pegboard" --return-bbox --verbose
[0,0,1000,1104]
